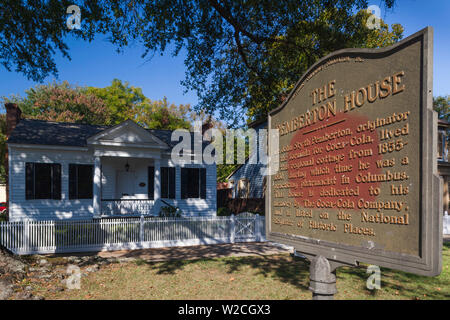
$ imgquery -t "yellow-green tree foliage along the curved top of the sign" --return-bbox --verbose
[244,18,403,120]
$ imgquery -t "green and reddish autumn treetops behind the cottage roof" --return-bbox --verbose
[0,79,194,182]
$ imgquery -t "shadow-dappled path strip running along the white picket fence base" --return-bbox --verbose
[98,242,292,261]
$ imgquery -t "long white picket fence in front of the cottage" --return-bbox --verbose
[0,214,265,255]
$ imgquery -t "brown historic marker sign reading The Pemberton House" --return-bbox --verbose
[266,28,442,275]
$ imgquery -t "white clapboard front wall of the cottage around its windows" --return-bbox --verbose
[9,147,217,221]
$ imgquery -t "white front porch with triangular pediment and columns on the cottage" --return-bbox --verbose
[87,121,173,218]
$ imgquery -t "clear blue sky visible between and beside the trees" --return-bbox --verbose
[0,0,450,111]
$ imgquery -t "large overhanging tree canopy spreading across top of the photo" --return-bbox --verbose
[0,0,401,123]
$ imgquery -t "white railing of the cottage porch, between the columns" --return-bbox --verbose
[102,199,154,216]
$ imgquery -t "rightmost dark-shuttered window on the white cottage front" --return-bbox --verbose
[181,168,206,199]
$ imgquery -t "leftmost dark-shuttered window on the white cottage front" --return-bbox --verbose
[25,162,61,200]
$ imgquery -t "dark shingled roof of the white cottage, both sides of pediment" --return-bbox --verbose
[7,119,193,148]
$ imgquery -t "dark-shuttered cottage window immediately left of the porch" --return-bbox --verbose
[69,163,94,199]
